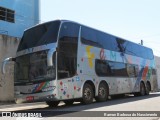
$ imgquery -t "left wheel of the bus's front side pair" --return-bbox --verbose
[82,84,94,104]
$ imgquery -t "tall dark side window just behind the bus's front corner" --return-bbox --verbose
[58,22,79,79]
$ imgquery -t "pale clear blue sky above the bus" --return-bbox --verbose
[40,0,160,56]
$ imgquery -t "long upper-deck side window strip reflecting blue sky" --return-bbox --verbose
[81,27,153,59]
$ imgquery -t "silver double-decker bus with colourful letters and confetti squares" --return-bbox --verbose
[2,20,155,106]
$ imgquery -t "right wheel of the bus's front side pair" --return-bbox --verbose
[96,83,108,102]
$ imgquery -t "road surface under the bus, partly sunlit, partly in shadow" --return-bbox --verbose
[0,93,160,120]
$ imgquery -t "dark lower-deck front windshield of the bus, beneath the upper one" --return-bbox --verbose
[15,51,56,82]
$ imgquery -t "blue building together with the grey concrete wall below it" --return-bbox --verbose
[0,0,40,101]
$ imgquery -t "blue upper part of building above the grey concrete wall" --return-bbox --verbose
[0,0,40,37]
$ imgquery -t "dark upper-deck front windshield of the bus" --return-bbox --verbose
[18,21,60,51]
